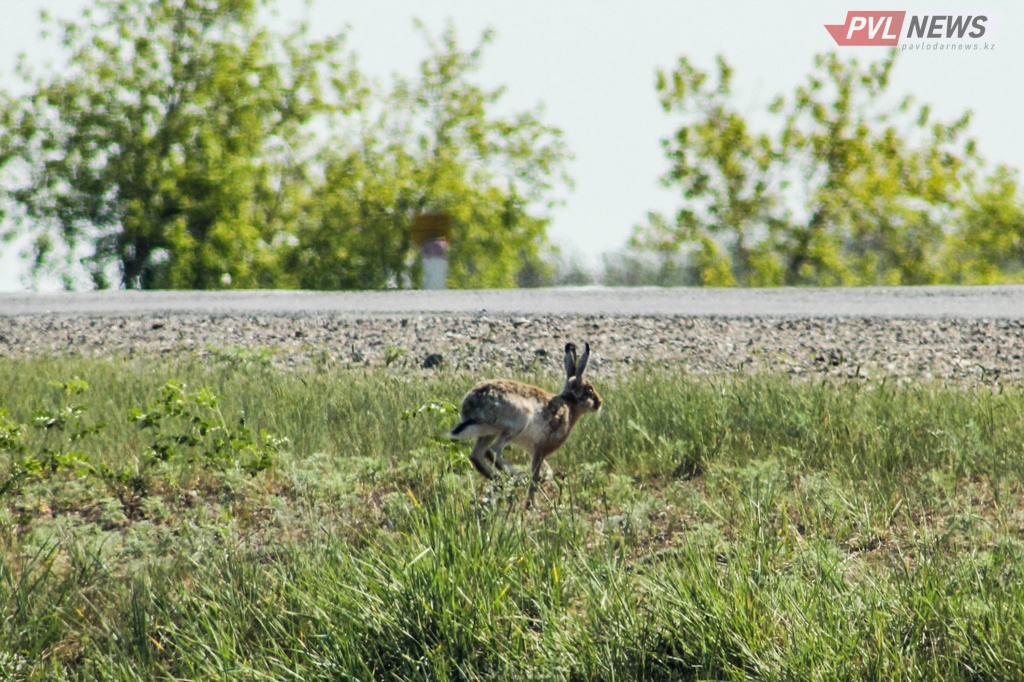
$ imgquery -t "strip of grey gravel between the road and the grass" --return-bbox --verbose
[0,313,1024,383]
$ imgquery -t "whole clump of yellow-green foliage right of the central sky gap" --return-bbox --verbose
[630,51,1024,286]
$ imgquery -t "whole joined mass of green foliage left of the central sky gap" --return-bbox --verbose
[0,6,568,289]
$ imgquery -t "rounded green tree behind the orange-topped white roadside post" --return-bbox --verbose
[287,24,570,289]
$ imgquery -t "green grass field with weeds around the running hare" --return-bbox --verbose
[0,355,1024,680]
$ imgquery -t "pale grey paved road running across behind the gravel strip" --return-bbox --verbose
[0,286,1024,319]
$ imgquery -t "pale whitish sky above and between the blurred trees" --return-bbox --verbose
[0,0,1024,291]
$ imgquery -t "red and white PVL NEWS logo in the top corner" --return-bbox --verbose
[825,10,995,51]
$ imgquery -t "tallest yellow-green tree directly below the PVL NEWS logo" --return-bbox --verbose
[771,51,977,285]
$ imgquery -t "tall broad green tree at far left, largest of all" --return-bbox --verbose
[0,0,357,289]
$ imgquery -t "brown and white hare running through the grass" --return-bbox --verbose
[449,343,601,508]
